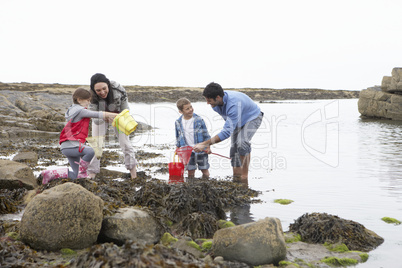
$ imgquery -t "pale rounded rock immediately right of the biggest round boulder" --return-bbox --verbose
[99,207,161,245]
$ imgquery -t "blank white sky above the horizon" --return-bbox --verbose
[0,0,402,90]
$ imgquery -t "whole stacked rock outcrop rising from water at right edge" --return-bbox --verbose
[358,68,402,120]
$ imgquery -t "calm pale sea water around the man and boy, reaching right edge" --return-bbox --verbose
[130,99,402,267]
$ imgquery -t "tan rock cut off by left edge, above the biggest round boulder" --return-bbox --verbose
[0,159,38,190]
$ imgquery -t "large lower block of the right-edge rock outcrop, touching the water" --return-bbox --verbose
[358,87,402,120]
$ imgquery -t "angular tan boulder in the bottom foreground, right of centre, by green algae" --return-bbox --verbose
[212,218,286,266]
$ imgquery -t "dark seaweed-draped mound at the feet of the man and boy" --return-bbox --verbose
[129,179,259,239]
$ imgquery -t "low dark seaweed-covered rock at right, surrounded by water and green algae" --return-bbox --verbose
[289,213,384,252]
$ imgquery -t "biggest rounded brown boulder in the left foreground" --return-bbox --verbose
[20,182,103,251]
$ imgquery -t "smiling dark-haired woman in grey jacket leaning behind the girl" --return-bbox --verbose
[88,73,137,179]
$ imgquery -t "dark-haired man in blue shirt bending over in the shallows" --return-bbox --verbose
[193,82,264,185]
